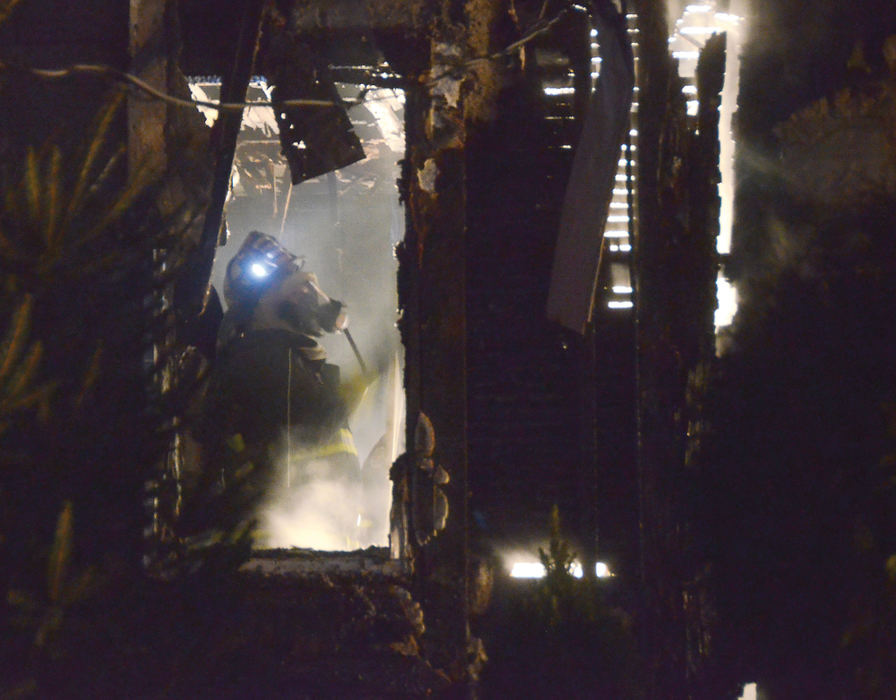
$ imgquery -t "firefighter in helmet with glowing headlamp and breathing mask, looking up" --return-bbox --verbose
[184,231,360,549]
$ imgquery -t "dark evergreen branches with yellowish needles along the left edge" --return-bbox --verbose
[0,91,210,695]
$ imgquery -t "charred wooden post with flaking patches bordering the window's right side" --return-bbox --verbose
[399,13,469,680]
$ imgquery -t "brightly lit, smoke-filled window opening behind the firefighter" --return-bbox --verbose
[190,78,405,551]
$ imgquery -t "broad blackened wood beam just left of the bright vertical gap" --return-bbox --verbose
[635,3,724,698]
